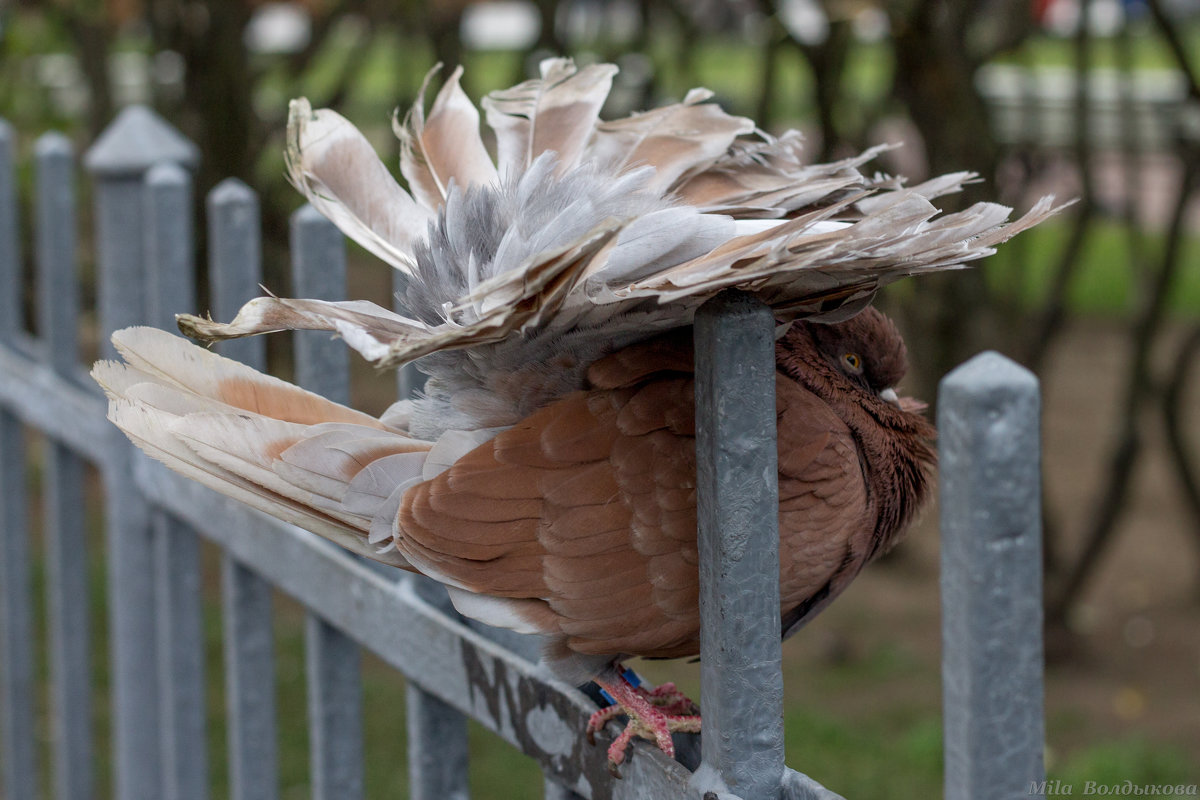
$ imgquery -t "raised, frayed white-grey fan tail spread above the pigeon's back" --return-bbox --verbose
[154,59,1063,433]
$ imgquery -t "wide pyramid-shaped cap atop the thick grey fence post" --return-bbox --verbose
[83,106,200,178]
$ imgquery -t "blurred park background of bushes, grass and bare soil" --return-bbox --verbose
[0,0,1200,799]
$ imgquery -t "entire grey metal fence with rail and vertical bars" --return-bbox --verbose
[0,107,1044,800]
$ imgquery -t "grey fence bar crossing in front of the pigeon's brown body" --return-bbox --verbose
[695,291,784,800]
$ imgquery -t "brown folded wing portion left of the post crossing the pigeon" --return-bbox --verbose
[397,367,696,655]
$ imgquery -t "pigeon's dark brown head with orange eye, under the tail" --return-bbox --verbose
[778,306,908,405]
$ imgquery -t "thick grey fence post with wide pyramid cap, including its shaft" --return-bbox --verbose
[84,106,199,800]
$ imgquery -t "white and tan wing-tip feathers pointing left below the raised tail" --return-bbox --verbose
[92,327,432,569]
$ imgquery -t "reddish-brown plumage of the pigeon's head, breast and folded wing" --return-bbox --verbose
[397,309,934,658]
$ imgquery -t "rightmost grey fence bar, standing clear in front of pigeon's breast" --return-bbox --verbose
[937,353,1045,800]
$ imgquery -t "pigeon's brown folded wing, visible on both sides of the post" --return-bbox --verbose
[397,335,870,657]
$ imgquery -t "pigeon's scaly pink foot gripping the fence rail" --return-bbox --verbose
[588,674,700,777]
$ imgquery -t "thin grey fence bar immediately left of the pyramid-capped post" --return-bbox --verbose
[35,133,92,798]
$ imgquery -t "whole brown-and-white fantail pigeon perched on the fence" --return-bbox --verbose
[92,59,1054,764]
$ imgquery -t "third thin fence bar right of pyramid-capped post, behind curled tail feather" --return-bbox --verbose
[289,205,362,800]
